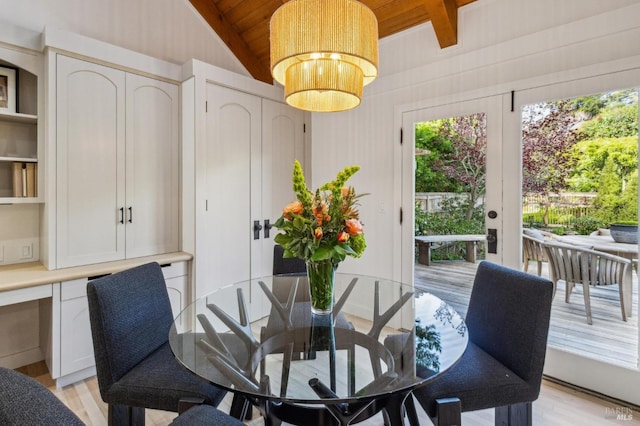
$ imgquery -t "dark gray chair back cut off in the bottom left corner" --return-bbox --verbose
[0,367,84,426]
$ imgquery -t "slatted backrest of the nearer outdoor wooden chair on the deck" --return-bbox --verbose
[543,242,631,285]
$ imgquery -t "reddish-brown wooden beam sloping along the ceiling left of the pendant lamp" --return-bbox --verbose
[189,0,273,84]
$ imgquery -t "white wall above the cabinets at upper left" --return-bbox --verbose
[0,0,248,75]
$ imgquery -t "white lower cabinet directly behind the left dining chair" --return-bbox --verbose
[49,262,188,386]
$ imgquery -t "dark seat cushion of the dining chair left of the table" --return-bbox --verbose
[105,342,226,412]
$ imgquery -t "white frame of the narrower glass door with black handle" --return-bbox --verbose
[401,96,510,282]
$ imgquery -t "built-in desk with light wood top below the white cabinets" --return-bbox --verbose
[0,252,192,386]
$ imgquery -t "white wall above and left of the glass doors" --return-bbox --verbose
[311,0,640,279]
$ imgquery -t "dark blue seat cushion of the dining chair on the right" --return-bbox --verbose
[414,342,538,417]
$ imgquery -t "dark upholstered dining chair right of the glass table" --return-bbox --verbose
[414,261,553,425]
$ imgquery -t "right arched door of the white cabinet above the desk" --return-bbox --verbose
[125,74,180,258]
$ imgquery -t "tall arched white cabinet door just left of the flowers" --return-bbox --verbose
[196,84,261,297]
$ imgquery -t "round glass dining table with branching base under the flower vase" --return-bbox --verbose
[169,273,468,425]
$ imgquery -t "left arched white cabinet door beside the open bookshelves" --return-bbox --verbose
[56,55,125,268]
